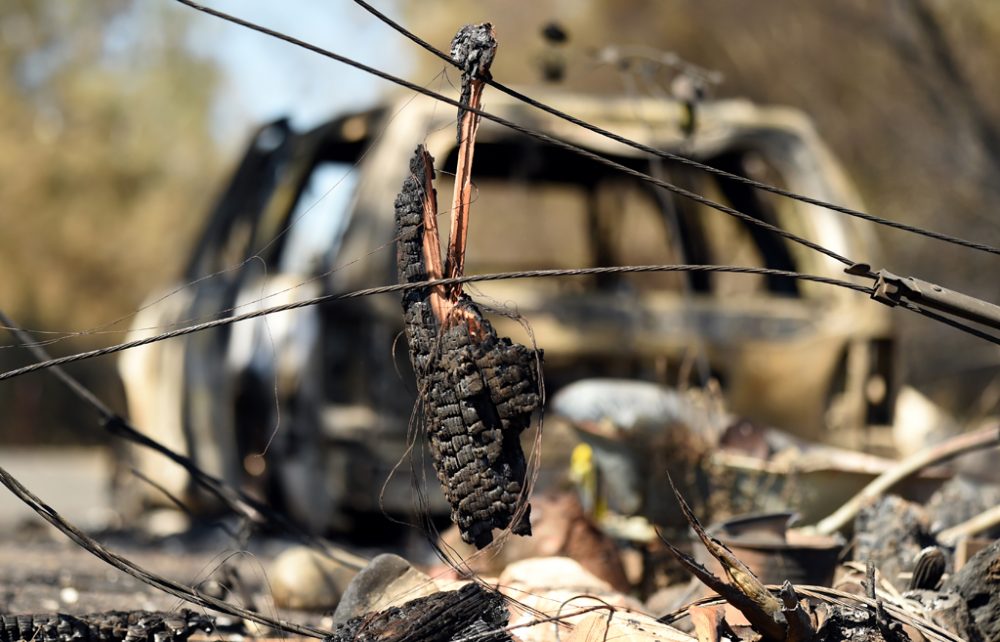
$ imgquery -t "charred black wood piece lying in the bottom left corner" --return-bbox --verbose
[0,610,213,642]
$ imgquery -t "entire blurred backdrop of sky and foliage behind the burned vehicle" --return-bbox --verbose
[0,0,1000,443]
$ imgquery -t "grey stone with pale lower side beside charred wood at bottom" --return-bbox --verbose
[333,553,441,625]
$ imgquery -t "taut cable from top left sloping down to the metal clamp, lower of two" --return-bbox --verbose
[170,0,852,268]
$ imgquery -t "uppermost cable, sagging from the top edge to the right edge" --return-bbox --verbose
[350,0,1000,255]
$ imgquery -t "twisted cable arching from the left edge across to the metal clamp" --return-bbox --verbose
[0,264,874,381]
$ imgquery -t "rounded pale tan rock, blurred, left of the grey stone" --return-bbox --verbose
[268,546,357,611]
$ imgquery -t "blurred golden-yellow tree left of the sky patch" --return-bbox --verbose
[0,0,220,440]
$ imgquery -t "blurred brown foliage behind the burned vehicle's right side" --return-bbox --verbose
[406,0,1000,412]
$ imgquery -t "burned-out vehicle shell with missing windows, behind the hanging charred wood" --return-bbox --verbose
[120,92,897,531]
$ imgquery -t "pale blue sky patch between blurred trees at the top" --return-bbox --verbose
[184,0,410,144]
